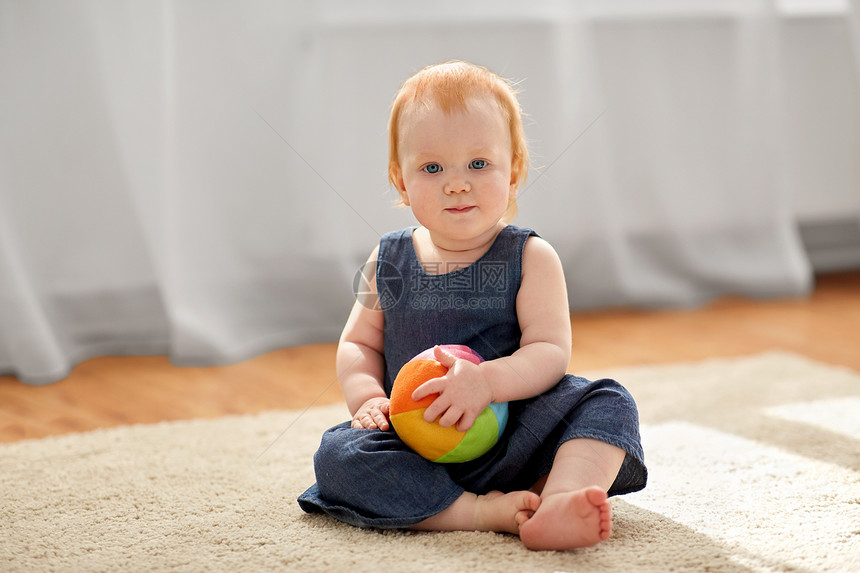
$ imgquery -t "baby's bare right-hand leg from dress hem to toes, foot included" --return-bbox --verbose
[518,439,625,550]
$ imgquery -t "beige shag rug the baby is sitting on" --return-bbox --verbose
[0,352,860,573]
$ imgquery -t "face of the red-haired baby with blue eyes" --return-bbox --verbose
[397,98,516,244]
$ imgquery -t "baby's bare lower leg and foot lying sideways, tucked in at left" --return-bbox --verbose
[410,491,540,533]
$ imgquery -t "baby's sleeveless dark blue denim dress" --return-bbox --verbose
[298,225,647,528]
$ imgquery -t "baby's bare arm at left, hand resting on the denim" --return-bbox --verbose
[336,247,388,430]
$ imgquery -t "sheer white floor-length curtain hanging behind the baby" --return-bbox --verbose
[0,0,852,383]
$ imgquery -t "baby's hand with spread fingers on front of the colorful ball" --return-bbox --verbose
[412,346,493,432]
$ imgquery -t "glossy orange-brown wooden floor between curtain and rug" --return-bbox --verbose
[0,271,860,442]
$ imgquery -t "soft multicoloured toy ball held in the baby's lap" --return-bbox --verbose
[389,344,508,463]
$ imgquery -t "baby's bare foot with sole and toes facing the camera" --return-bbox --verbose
[520,487,612,550]
